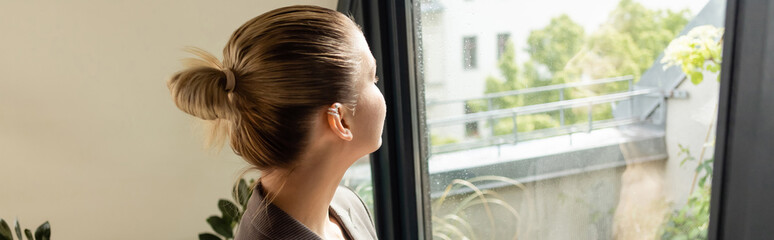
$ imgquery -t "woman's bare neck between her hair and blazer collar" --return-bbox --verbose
[260,148,354,236]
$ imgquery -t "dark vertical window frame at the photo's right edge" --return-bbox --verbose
[708,0,774,239]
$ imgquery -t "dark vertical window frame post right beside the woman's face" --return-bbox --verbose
[338,0,432,240]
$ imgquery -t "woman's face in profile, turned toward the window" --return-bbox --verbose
[334,27,387,157]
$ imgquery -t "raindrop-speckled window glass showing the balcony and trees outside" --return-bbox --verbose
[414,0,725,239]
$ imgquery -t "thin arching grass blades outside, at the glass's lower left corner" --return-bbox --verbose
[431,176,534,240]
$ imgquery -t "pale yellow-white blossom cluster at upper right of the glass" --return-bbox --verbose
[661,25,723,84]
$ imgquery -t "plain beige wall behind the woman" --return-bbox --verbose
[0,0,336,239]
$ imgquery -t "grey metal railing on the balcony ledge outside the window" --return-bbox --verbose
[427,76,662,153]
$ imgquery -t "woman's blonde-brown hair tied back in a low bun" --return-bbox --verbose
[167,6,363,210]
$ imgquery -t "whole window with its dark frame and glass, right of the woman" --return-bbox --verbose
[348,0,774,239]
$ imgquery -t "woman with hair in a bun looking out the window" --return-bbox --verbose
[168,6,386,240]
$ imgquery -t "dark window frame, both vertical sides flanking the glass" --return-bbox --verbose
[338,0,774,240]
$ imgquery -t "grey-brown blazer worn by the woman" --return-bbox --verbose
[234,184,377,240]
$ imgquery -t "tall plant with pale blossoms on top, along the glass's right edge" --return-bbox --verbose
[661,25,723,239]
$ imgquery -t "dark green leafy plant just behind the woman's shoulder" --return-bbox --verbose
[199,179,255,240]
